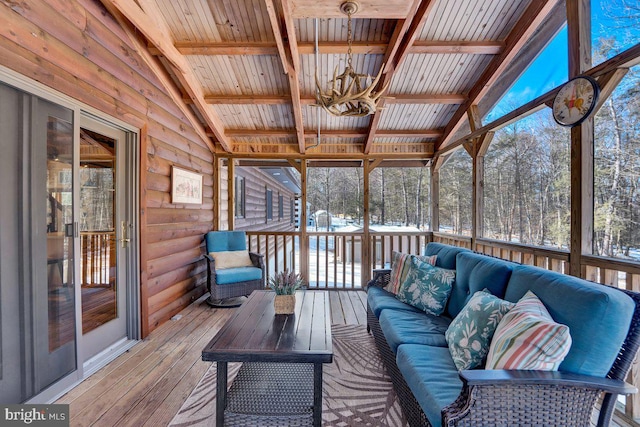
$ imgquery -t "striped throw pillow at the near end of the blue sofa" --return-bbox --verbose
[486,291,571,371]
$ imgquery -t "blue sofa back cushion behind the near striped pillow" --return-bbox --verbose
[505,265,634,377]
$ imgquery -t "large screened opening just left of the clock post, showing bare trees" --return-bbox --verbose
[482,109,571,249]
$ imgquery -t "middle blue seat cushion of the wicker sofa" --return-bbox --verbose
[379,309,451,353]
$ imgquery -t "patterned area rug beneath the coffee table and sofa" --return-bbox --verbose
[170,325,407,427]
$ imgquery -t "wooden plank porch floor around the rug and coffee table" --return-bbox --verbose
[56,291,638,427]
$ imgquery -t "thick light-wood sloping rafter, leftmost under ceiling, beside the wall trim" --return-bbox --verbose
[102,0,231,151]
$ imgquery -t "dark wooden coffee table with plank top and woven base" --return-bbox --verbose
[202,291,333,426]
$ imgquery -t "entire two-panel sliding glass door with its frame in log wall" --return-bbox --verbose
[0,82,139,403]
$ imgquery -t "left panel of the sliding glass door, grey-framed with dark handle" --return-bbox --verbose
[0,84,77,403]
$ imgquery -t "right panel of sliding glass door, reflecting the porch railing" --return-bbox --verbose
[78,116,127,362]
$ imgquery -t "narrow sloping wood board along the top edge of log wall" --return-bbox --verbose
[96,0,216,153]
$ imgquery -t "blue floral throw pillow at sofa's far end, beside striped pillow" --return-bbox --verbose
[396,257,456,316]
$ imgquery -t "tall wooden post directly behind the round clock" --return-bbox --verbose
[567,0,593,277]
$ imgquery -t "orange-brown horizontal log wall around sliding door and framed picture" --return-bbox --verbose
[0,0,214,336]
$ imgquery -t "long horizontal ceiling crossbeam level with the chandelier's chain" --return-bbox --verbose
[161,40,504,56]
